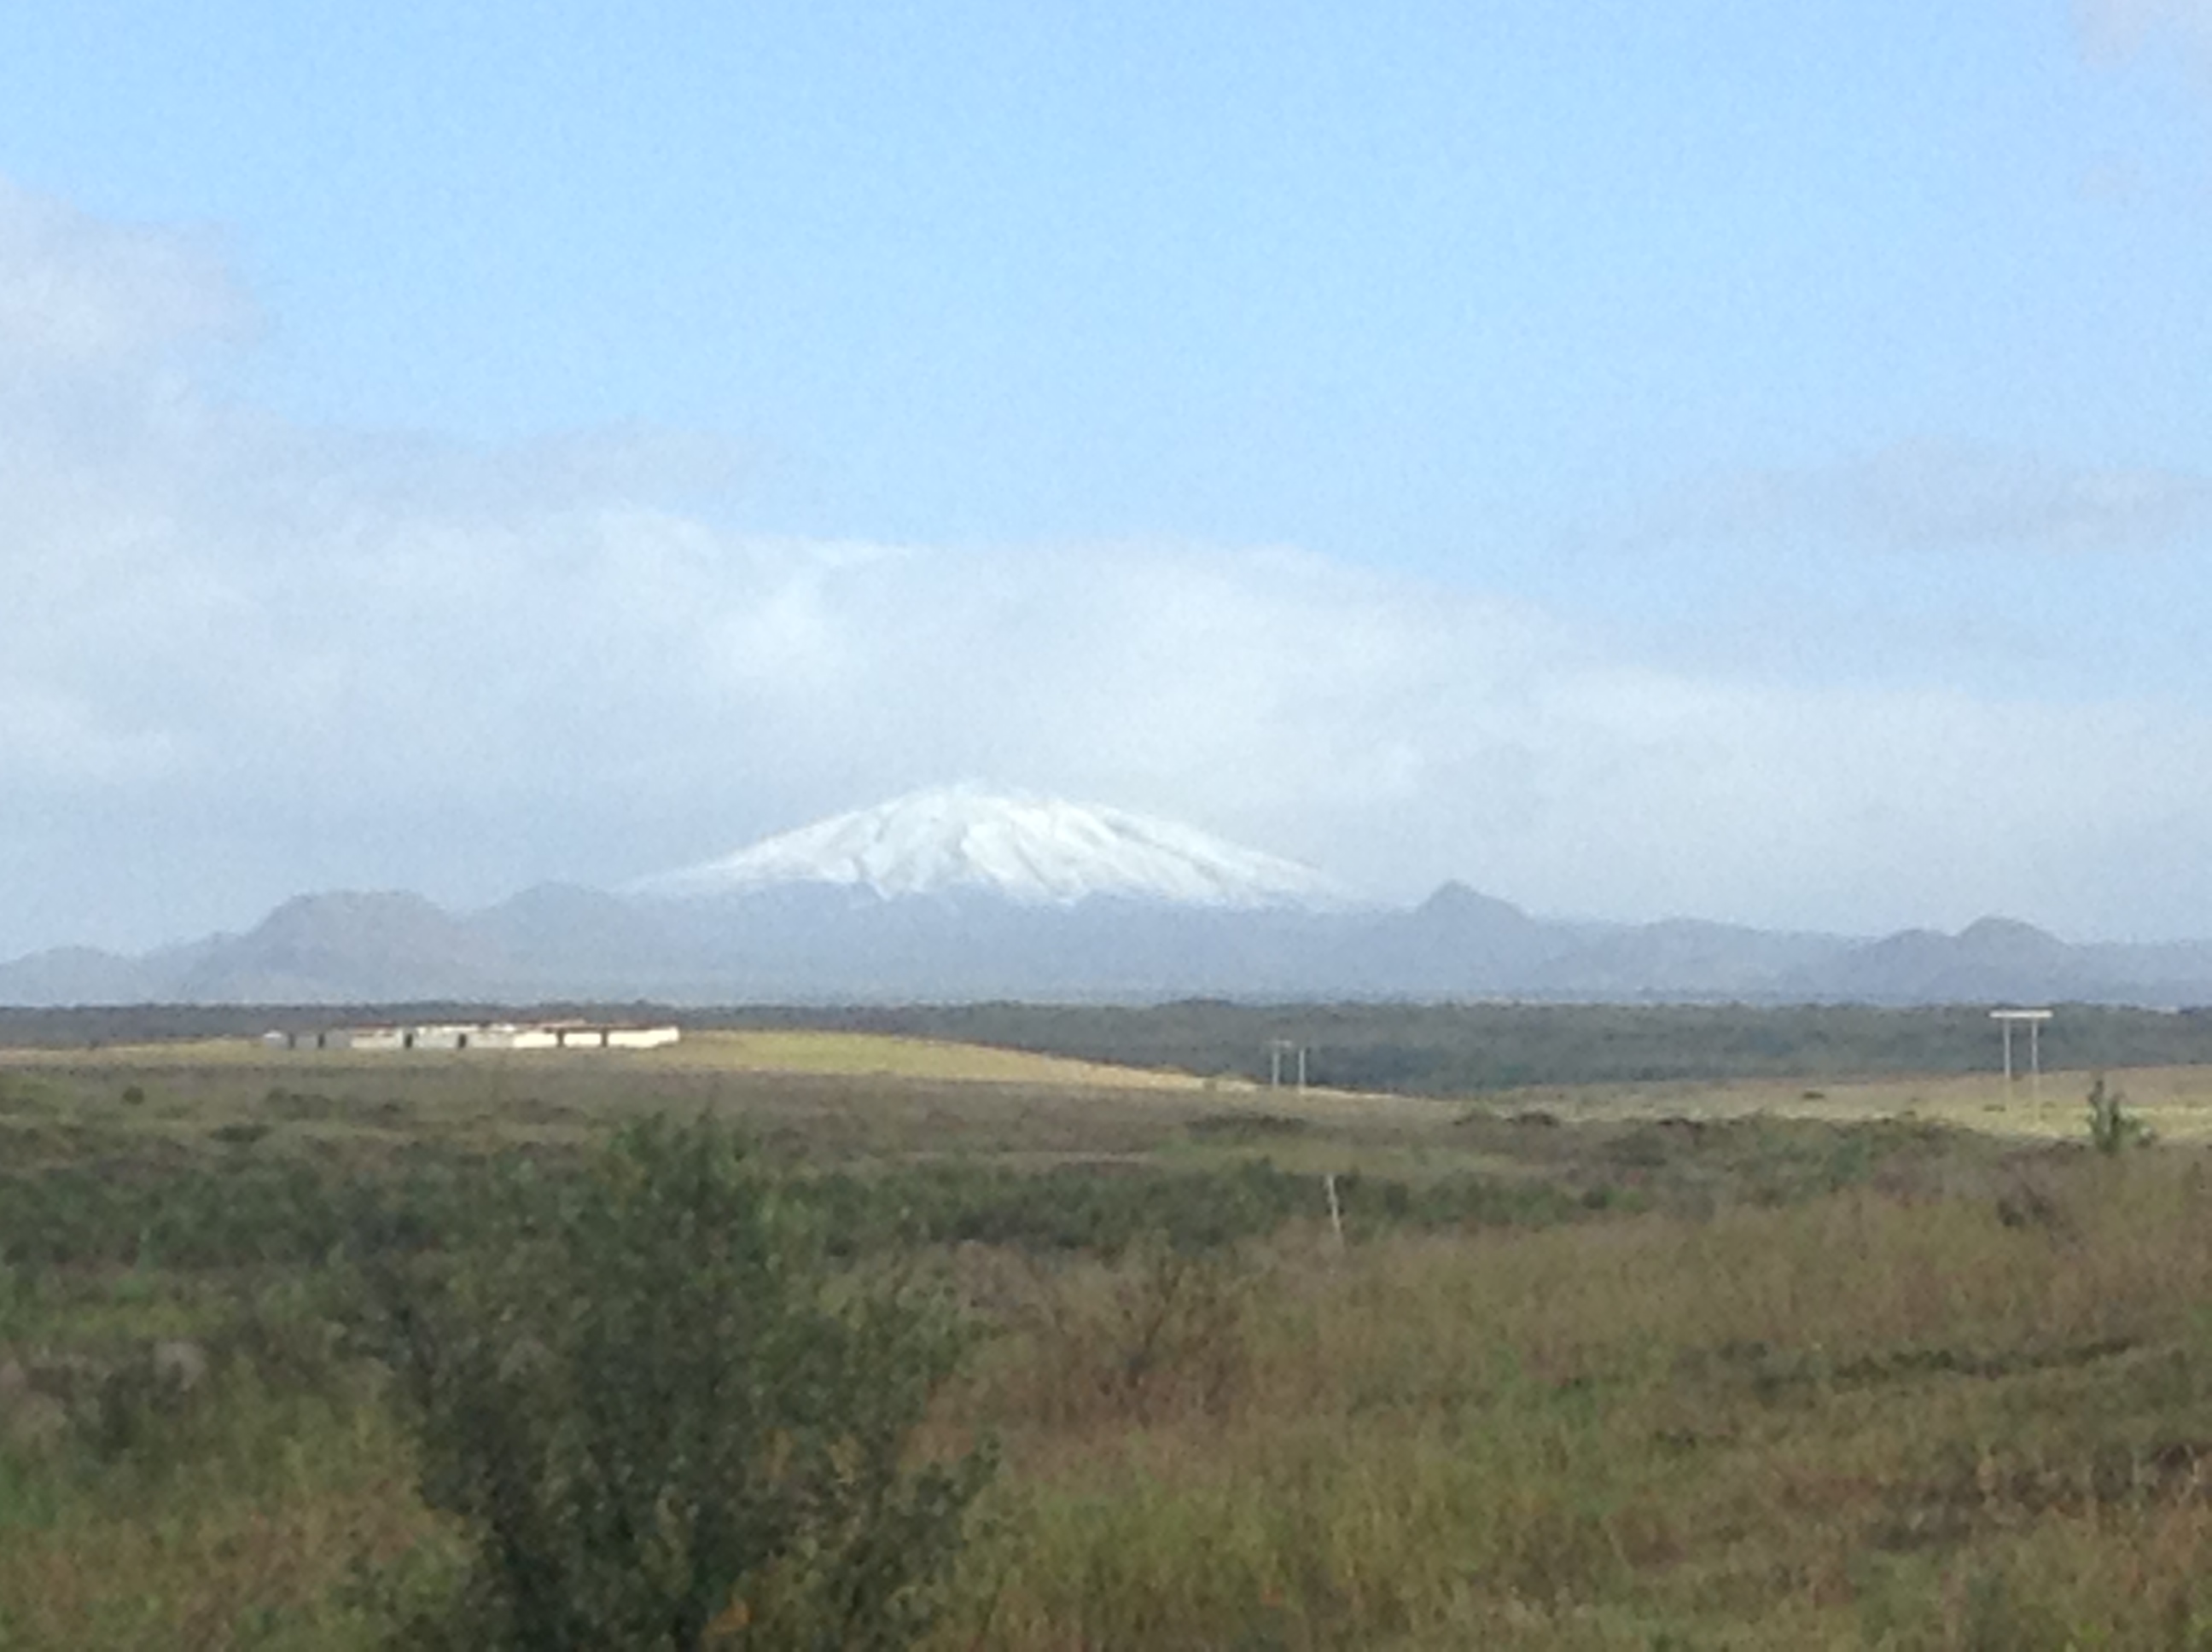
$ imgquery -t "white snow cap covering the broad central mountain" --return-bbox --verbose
[628,785,1349,909]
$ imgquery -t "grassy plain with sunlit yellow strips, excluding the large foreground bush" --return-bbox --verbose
[0,1031,2212,1652]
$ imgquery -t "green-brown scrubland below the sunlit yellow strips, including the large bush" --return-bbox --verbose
[0,1039,2212,1652]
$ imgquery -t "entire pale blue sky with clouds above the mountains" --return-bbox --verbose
[0,0,2212,953]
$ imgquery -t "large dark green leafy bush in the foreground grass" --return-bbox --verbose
[369,1121,987,1652]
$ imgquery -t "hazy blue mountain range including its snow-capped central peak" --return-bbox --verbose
[0,785,2212,1006]
